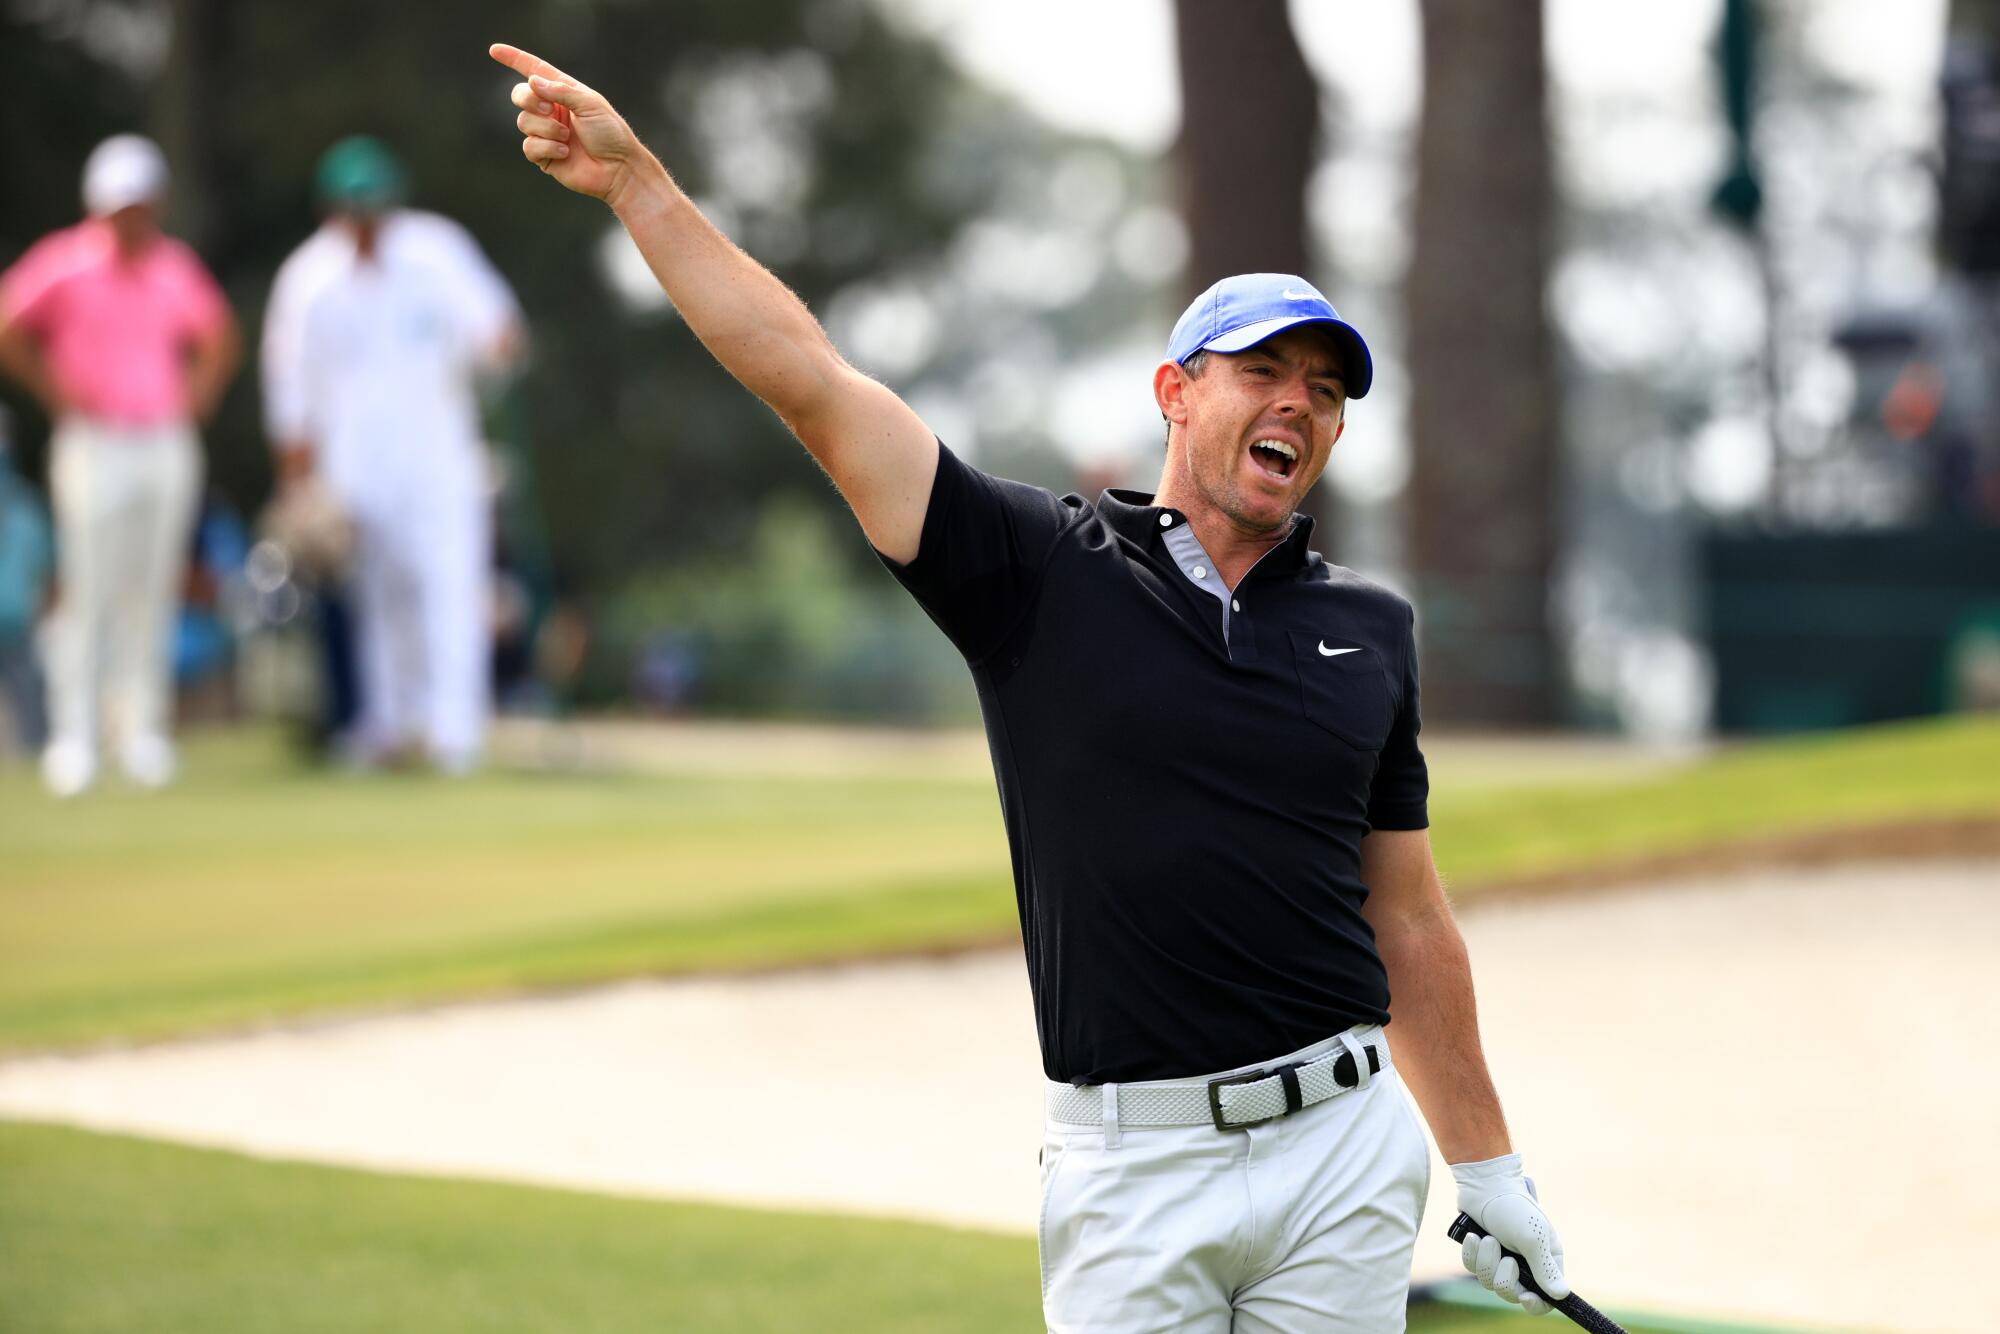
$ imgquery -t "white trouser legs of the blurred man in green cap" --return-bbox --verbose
[342,480,492,768]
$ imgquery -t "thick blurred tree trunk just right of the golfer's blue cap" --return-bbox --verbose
[1406,0,1560,726]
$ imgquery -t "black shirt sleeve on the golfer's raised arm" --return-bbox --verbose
[876,442,1078,664]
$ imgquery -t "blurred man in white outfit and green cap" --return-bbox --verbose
[264,138,522,772]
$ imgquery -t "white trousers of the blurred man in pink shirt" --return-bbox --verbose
[48,418,202,750]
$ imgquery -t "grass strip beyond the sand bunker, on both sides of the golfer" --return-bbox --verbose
[0,720,2000,1050]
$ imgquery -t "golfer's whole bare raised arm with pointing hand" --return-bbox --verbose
[490,44,938,562]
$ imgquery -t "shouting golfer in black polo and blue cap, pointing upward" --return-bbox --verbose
[492,46,1568,1334]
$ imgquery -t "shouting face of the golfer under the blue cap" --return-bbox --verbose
[1186,328,1348,532]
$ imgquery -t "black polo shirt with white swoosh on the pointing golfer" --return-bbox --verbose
[884,446,1428,1084]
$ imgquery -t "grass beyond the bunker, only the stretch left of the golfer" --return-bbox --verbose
[0,734,1014,1048]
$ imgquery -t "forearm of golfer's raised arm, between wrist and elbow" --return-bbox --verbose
[612,158,844,424]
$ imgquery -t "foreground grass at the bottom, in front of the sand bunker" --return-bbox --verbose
[0,1120,1704,1334]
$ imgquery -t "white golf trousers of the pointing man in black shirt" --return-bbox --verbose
[1040,1026,1430,1334]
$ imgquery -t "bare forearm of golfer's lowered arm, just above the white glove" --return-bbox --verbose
[1376,912,1512,1162]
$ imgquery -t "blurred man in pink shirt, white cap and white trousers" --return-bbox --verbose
[0,134,240,796]
